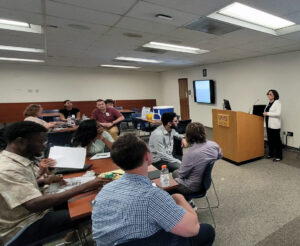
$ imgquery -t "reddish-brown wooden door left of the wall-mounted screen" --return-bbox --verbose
[178,78,190,120]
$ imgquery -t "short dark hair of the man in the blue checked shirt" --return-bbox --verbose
[110,133,149,170]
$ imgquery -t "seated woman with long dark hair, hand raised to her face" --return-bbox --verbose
[72,120,114,155]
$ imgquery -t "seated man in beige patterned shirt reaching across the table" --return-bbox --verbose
[0,121,106,246]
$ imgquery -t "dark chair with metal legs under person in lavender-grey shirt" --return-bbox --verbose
[184,161,219,228]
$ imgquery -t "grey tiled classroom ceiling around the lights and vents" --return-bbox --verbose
[0,0,300,71]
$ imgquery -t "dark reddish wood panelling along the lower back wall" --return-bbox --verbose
[0,99,156,123]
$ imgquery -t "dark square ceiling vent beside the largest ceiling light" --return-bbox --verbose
[185,17,241,36]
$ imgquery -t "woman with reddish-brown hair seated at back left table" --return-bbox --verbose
[24,104,58,129]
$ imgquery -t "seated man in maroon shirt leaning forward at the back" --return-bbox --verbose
[91,99,124,140]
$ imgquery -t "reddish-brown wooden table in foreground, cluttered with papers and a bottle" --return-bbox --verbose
[64,158,178,220]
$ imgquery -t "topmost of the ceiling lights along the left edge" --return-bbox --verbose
[0,19,43,34]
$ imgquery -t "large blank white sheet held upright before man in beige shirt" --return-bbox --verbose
[49,146,86,169]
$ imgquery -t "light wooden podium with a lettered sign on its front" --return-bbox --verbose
[212,109,264,164]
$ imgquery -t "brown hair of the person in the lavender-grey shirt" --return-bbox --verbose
[185,122,206,145]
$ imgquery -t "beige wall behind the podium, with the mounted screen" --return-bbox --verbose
[161,52,300,148]
